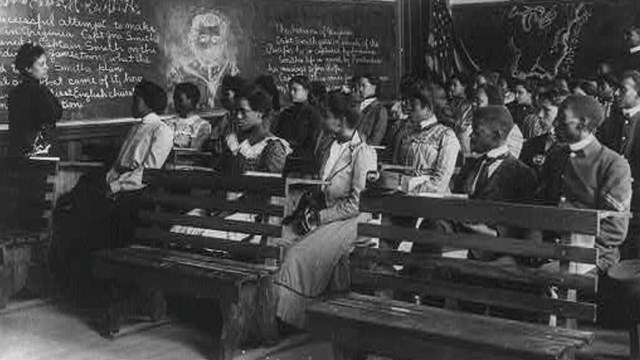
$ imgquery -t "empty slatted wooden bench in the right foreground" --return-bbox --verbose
[308,195,625,359]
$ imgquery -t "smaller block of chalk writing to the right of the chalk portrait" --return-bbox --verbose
[262,23,383,91]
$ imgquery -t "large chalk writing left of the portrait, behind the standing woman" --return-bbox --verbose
[0,0,160,119]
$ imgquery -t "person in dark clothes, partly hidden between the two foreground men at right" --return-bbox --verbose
[520,91,564,175]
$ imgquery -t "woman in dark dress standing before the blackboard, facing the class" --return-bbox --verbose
[8,43,62,157]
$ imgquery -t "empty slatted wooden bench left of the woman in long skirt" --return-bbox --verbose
[93,170,285,359]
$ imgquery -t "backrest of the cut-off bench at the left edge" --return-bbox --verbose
[0,158,58,239]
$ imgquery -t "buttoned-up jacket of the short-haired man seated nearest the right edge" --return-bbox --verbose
[538,140,631,270]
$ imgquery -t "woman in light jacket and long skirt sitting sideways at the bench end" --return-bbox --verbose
[276,92,377,329]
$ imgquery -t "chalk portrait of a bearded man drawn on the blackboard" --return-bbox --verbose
[168,10,239,108]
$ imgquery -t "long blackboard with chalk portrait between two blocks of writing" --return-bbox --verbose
[0,0,398,122]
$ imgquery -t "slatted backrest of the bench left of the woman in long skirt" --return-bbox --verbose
[139,170,285,262]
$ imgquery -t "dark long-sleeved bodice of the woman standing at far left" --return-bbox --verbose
[8,76,62,157]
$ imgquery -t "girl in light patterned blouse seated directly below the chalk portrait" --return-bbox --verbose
[167,83,211,150]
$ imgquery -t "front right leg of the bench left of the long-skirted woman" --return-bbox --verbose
[218,284,257,360]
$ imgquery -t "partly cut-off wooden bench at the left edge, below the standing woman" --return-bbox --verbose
[0,158,58,309]
